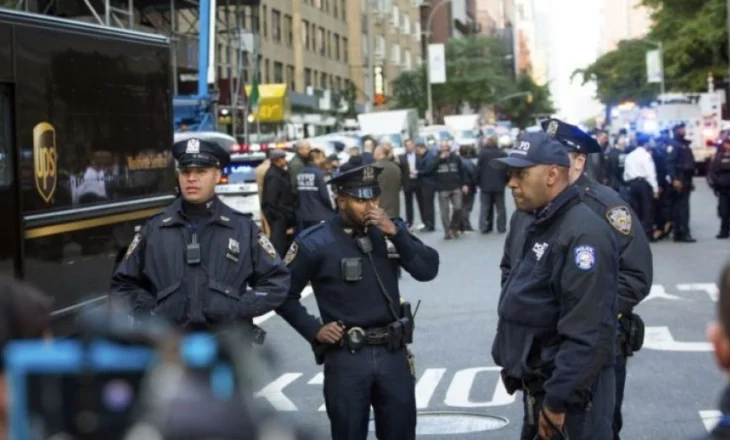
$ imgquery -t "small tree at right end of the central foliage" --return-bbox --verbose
[496,74,555,128]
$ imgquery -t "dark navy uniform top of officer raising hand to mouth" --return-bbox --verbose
[276,216,439,342]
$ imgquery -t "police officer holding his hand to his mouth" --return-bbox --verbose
[277,165,432,440]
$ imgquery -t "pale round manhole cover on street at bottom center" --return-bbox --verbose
[370,411,509,435]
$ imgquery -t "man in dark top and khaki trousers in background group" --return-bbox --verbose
[433,141,469,240]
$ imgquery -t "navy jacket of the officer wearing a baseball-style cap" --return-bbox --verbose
[492,186,618,411]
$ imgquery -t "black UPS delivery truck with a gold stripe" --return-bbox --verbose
[0,9,175,332]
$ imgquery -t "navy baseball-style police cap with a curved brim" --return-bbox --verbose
[489,131,570,169]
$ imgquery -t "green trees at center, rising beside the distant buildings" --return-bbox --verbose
[391,37,552,127]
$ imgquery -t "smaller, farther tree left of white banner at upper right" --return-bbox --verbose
[573,40,659,105]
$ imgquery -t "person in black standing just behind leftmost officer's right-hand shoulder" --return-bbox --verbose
[261,150,298,256]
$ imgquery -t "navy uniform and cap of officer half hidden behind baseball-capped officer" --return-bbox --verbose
[543,119,654,439]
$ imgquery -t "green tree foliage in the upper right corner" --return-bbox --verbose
[574,0,728,104]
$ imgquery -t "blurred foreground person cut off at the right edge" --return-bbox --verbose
[701,264,730,440]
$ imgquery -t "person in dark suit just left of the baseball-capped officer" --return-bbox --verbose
[477,137,507,234]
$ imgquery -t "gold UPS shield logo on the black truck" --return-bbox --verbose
[33,122,58,203]
